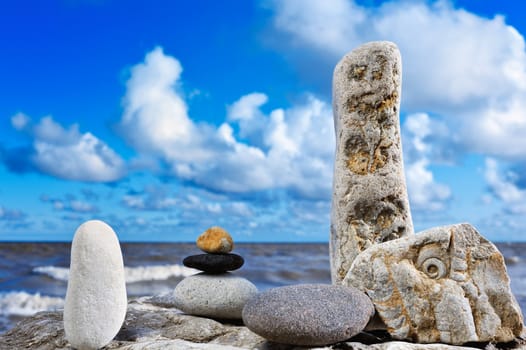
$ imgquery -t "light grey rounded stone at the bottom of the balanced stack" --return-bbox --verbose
[174,272,258,319]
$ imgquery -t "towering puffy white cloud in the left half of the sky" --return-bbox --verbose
[121,48,197,157]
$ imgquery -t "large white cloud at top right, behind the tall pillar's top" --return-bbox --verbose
[271,0,526,112]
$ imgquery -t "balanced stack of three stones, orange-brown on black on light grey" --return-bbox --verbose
[174,227,258,319]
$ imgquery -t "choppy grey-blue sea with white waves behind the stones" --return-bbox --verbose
[0,242,526,334]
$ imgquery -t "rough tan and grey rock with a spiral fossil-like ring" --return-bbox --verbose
[343,224,523,344]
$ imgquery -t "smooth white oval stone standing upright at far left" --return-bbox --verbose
[64,220,128,350]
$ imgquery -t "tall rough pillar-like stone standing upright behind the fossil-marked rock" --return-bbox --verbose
[330,42,414,284]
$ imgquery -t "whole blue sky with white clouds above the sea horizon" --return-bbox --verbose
[0,0,526,241]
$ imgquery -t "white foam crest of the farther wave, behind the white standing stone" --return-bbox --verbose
[33,264,199,283]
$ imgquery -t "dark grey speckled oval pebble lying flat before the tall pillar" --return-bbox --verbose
[242,284,374,346]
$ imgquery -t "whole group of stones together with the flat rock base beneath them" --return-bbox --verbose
[0,42,526,350]
